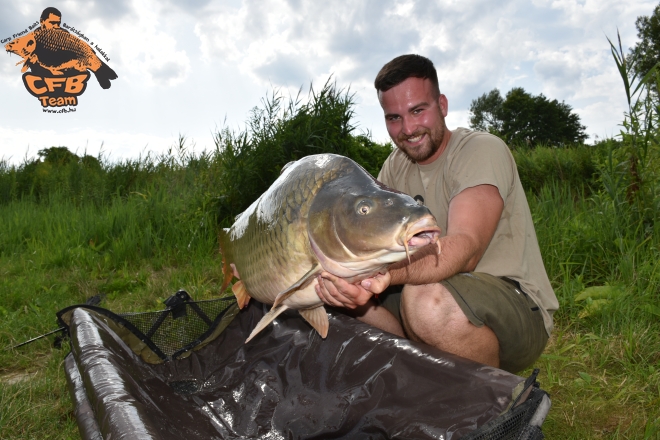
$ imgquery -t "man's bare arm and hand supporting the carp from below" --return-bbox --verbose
[316,185,504,309]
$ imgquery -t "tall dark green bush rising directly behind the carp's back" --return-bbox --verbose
[214,82,391,226]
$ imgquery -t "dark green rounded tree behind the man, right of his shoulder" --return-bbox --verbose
[470,87,587,146]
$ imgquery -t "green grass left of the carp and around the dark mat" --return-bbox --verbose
[0,188,222,439]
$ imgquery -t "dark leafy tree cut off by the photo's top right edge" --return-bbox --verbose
[627,4,660,83]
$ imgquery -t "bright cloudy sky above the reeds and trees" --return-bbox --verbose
[0,0,656,164]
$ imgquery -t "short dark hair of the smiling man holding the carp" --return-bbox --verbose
[374,54,440,96]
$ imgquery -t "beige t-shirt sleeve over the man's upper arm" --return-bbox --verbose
[446,134,516,202]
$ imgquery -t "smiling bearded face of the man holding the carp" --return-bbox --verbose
[378,78,448,165]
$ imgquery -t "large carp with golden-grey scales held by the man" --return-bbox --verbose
[220,154,440,342]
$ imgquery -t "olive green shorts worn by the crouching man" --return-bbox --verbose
[379,272,548,373]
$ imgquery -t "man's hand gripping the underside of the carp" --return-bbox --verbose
[315,272,390,309]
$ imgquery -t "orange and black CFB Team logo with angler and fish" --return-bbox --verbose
[3,8,117,113]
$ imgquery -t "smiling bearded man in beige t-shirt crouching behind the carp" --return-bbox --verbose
[316,55,558,372]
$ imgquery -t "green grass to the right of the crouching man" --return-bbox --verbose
[528,183,660,439]
